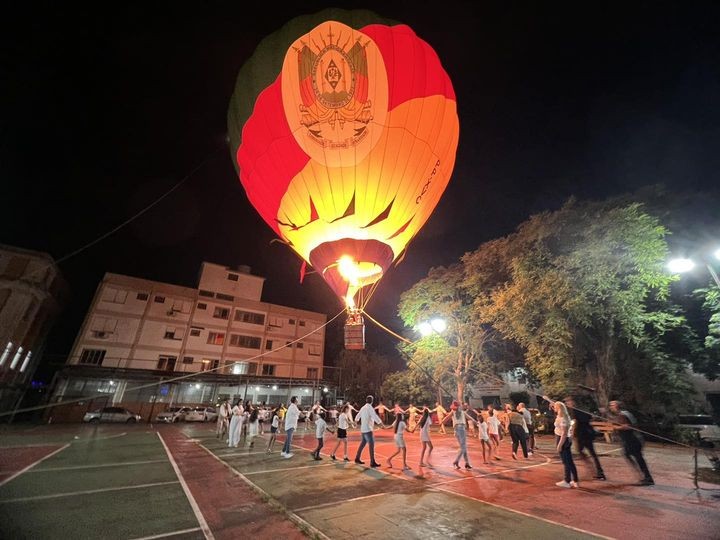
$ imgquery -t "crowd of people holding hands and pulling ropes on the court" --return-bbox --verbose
[212,396,654,488]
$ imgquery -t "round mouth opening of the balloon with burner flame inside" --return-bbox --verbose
[310,238,393,308]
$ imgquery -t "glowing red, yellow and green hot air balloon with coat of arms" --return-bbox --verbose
[228,9,459,348]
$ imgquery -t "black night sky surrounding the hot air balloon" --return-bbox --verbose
[0,0,720,370]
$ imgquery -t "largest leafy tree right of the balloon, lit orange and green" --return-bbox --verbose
[463,199,683,410]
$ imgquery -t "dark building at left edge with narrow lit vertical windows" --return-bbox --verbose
[0,244,67,412]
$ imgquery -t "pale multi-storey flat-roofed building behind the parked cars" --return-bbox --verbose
[51,262,327,419]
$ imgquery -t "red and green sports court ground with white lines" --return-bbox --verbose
[0,424,720,540]
